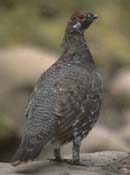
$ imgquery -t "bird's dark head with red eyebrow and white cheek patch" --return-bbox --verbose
[68,11,98,33]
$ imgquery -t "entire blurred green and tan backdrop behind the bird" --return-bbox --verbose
[0,0,130,161]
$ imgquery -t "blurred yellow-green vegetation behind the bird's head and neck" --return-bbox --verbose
[0,0,130,71]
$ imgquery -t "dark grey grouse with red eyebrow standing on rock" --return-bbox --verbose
[11,10,103,166]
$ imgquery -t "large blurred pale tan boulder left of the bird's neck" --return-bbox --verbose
[0,46,57,89]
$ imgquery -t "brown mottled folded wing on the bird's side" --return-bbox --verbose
[52,73,91,142]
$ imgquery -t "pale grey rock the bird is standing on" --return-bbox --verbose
[0,151,130,175]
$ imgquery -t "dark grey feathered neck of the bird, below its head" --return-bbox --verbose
[62,33,94,65]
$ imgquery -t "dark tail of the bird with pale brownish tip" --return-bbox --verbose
[11,137,44,166]
